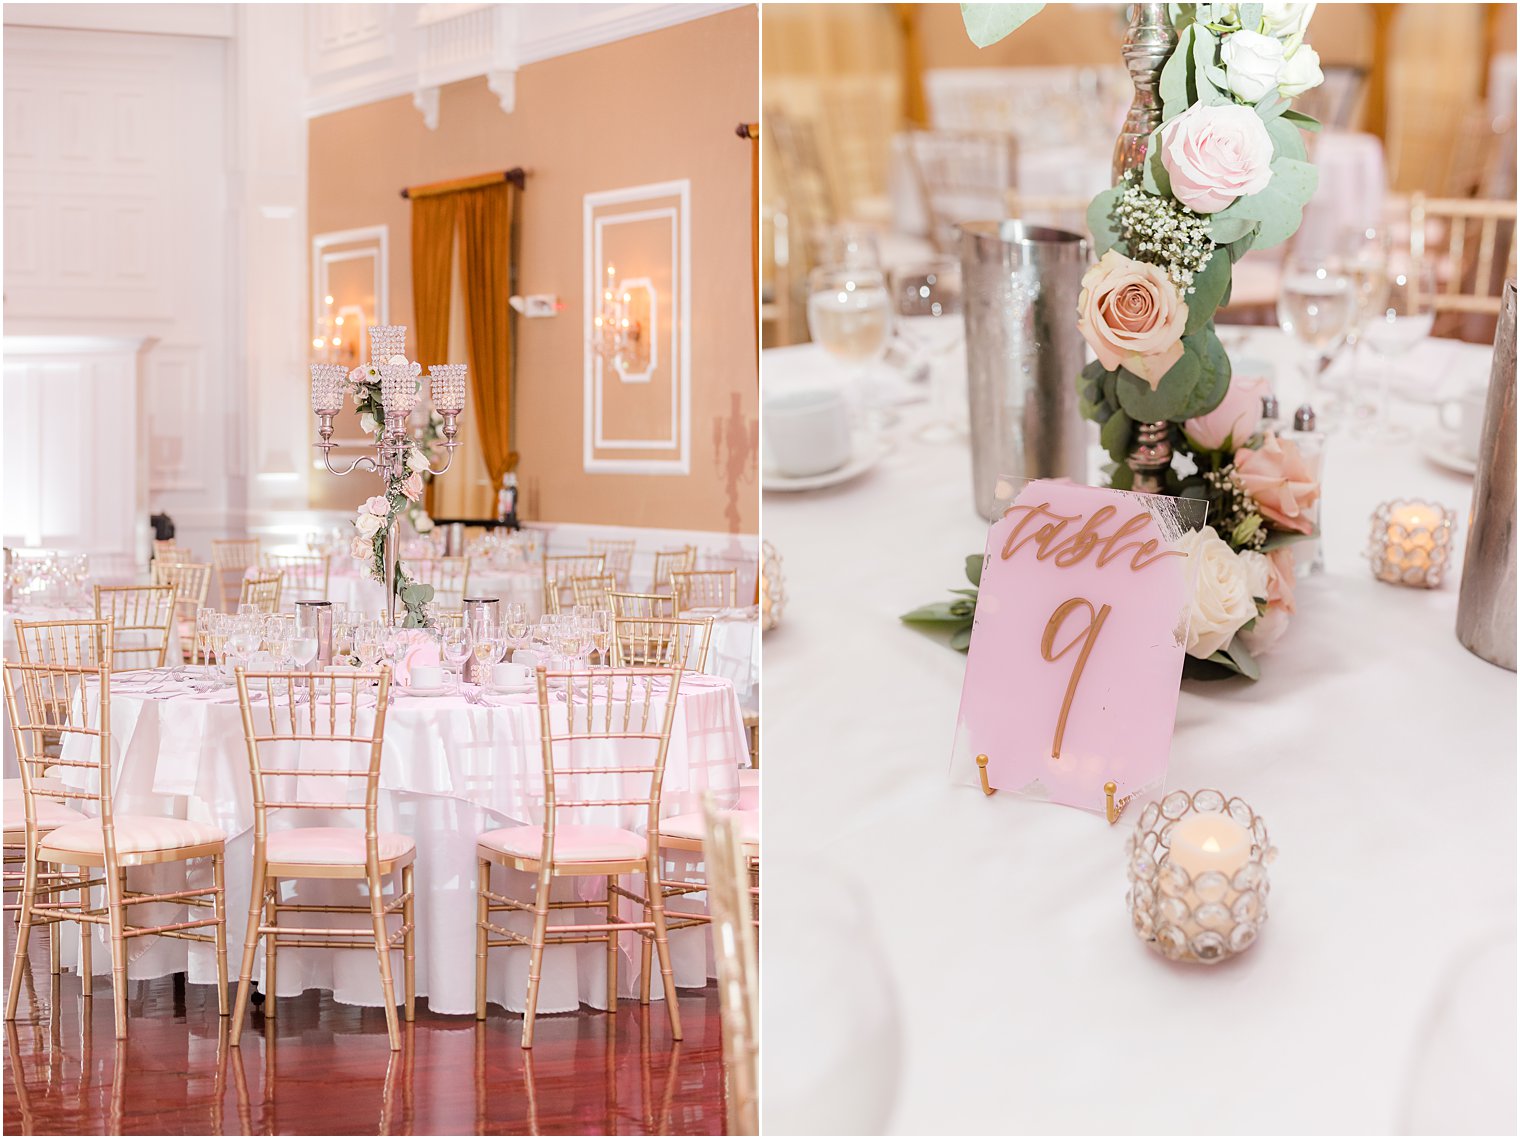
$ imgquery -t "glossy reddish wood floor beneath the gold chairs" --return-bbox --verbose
[5,914,724,1134]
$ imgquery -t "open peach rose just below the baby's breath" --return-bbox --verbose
[1076,249,1187,391]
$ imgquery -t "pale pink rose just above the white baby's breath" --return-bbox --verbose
[1161,103,1272,213]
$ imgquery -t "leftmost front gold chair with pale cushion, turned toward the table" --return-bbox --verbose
[5,647,226,1040]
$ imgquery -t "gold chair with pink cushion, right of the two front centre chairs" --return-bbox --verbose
[476,668,681,1048]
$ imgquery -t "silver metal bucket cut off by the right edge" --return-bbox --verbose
[1456,281,1515,672]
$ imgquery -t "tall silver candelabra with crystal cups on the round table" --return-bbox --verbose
[312,324,467,625]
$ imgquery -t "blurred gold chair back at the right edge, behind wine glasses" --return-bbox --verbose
[1409,193,1515,316]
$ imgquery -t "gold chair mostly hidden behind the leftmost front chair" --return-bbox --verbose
[5,620,111,991]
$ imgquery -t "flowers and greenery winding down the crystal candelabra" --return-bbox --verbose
[348,356,444,628]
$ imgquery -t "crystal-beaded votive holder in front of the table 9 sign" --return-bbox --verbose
[1125,789,1277,964]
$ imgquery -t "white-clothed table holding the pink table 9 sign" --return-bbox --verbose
[765,330,1515,1134]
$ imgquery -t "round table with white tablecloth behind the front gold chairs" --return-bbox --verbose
[55,674,748,1014]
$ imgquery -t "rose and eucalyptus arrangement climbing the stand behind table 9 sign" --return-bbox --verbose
[904,3,1324,680]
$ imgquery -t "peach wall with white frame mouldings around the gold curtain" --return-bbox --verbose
[309,6,760,532]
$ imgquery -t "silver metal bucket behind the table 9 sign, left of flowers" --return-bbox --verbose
[958,221,1091,522]
